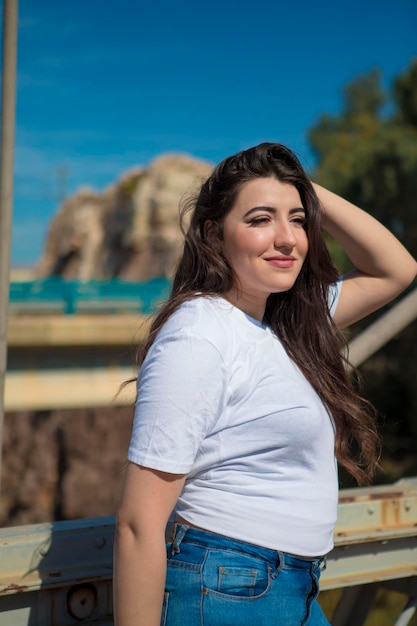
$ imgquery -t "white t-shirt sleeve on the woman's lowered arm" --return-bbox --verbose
[128,321,227,474]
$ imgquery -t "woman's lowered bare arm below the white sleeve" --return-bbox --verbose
[113,463,185,626]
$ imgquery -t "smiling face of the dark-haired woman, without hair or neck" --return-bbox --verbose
[221,178,308,304]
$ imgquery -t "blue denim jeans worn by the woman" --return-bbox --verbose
[161,524,329,626]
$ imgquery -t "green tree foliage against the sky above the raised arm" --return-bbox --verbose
[309,59,417,254]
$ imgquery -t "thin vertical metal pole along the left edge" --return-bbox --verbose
[0,0,18,490]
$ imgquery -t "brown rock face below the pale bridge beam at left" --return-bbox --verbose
[0,407,133,526]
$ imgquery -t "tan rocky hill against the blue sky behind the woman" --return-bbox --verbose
[35,155,211,280]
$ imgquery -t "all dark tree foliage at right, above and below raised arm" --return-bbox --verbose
[309,58,417,474]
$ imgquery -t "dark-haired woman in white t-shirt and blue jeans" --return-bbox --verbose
[114,143,416,626]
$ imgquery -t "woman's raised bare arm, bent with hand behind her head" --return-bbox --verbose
[313,183,417,328]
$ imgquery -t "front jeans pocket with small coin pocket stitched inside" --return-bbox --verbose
[203,550,271,599]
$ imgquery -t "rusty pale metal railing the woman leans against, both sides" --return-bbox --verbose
[0,478,417,626]
